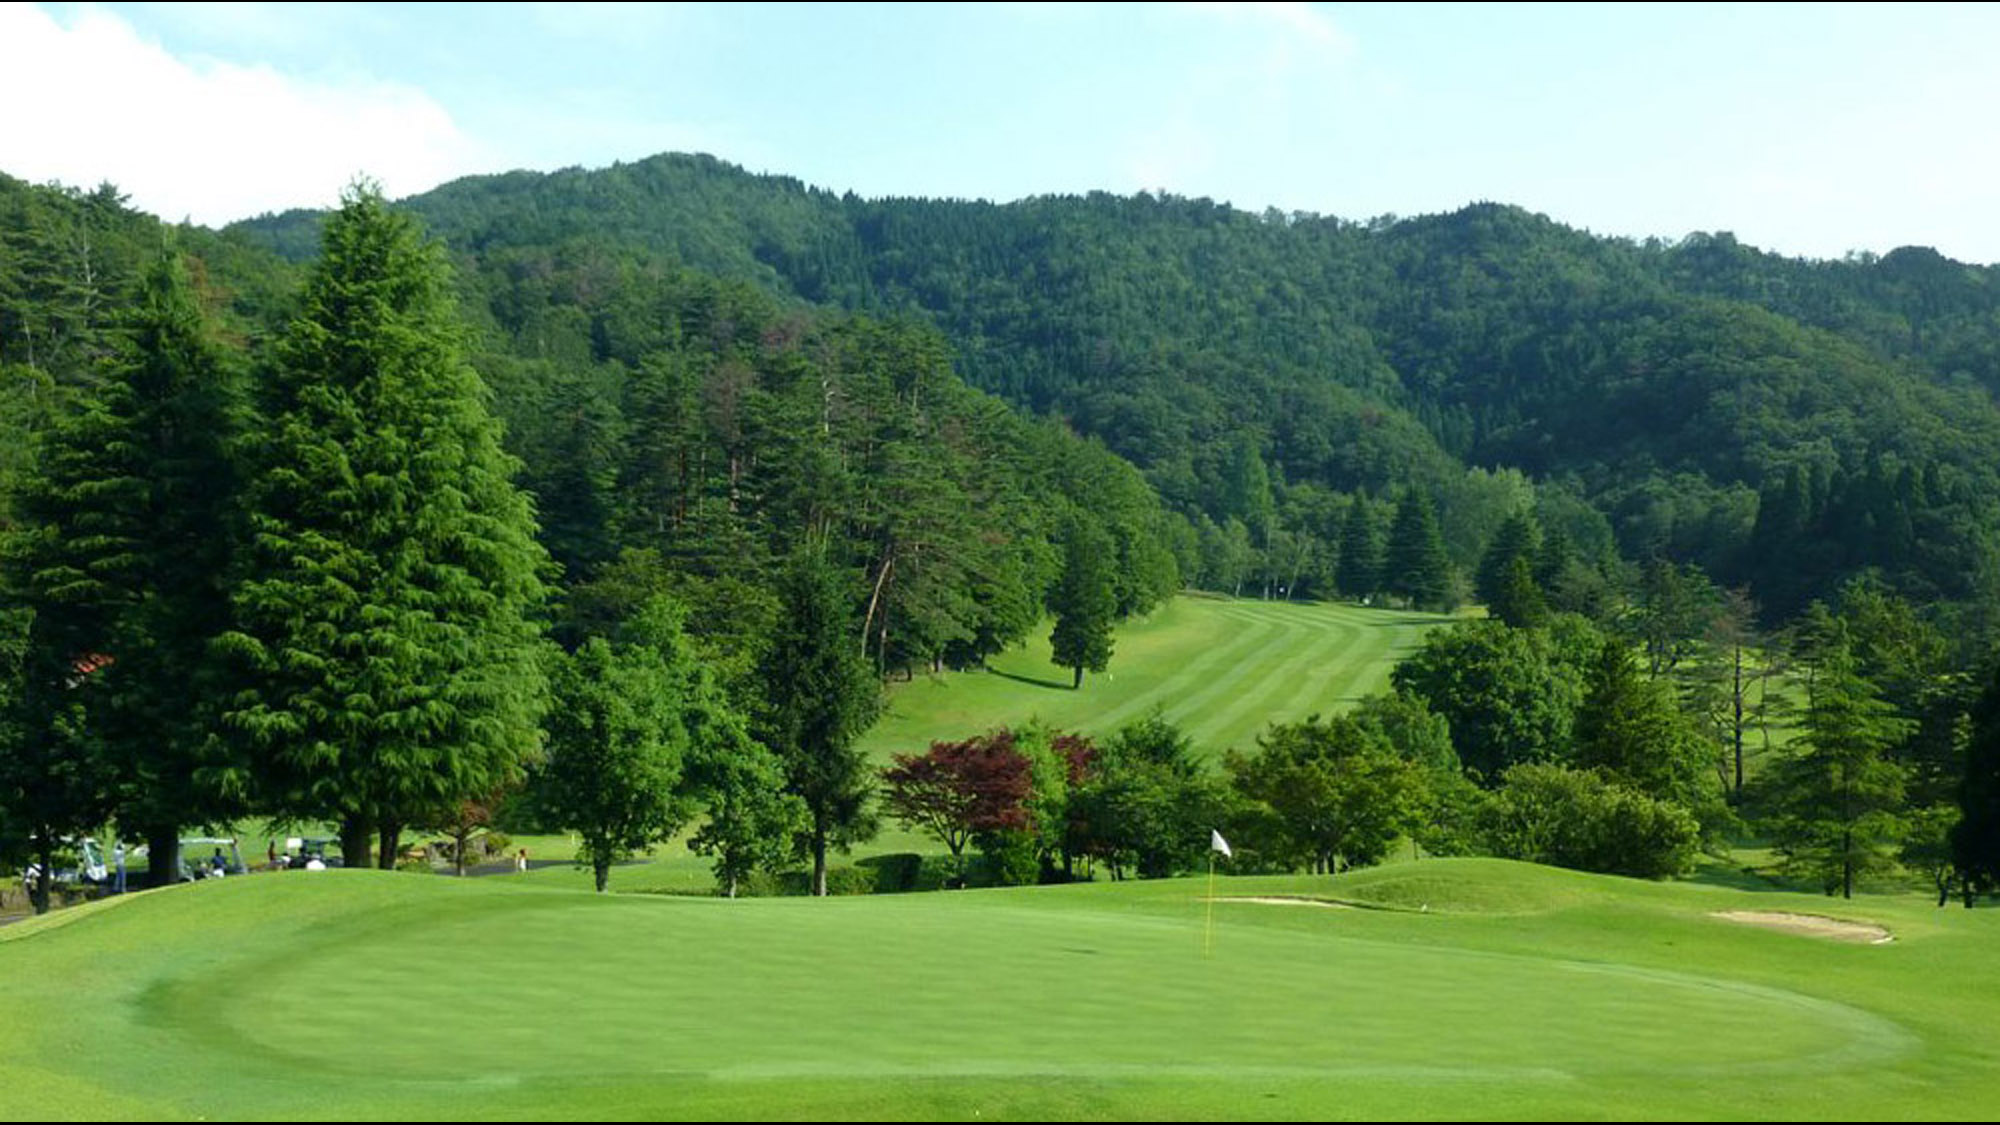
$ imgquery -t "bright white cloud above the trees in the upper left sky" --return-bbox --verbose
[0,4,494,224]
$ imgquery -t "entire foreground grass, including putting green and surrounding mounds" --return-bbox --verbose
[0,861,2000,1119]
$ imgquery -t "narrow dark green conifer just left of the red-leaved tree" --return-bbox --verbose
[754,546,880,895]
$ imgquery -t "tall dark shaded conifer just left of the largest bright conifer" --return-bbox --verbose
[16,252,242,885]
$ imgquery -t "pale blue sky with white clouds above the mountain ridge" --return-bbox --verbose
[11,2,2000,262]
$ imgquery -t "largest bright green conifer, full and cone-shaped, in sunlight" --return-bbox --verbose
[228,186,546,867]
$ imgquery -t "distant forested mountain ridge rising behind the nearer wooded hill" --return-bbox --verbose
[232,156,2000,632]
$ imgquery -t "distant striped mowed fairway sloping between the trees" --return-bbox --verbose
[864,597,1452,759]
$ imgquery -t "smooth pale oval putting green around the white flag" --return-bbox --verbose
[227,884,1902,1079]
